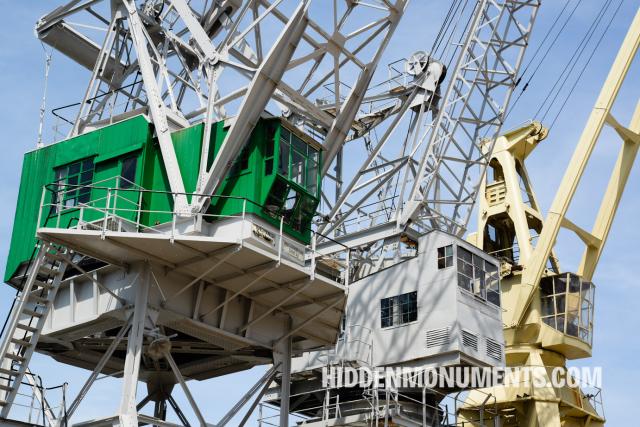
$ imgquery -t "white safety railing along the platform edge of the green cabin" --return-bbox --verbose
[37,176,354,286]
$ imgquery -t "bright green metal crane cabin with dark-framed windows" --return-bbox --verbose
[5,115,321,283]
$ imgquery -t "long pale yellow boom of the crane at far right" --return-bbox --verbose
[513,8,640,326]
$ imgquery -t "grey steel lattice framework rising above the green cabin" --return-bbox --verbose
[37,0,408,214]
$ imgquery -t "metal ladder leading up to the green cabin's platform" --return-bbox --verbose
[0,242,69,419]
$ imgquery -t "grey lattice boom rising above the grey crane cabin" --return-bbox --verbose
[320,0,540,242]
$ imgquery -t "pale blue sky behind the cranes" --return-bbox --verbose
[0,0,640,425]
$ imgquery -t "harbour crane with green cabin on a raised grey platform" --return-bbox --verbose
[0,0,408,426]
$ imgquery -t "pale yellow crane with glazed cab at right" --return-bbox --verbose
[459,9,640,427]
